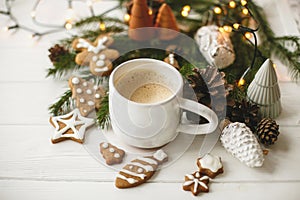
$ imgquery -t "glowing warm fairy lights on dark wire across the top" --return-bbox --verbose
[0,0,268,86]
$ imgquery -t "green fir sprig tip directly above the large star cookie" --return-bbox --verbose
[48,90,73,116]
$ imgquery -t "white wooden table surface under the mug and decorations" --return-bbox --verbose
[0,0,300,200]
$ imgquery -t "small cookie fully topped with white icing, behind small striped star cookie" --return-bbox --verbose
[197,154,223,178]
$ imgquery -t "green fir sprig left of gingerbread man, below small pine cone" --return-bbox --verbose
[46,52,79,77]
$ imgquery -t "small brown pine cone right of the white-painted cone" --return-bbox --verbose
[256,118,280,145]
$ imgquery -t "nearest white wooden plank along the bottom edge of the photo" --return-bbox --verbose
[0,180,300,200]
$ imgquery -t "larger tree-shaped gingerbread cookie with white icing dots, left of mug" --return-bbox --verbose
[69,76,105,116]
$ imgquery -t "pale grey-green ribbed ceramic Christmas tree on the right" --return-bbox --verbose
[247,59,281,118]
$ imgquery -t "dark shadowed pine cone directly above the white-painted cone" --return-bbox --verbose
[227,100,261,132]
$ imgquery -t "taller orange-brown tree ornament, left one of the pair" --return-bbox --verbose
[128,0,154,41]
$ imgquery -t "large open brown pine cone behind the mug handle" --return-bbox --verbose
[185,66,229,123]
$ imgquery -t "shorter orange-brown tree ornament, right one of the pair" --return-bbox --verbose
[155,3,179,40]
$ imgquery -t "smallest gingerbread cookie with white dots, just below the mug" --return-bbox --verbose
[100,142,125,165]
